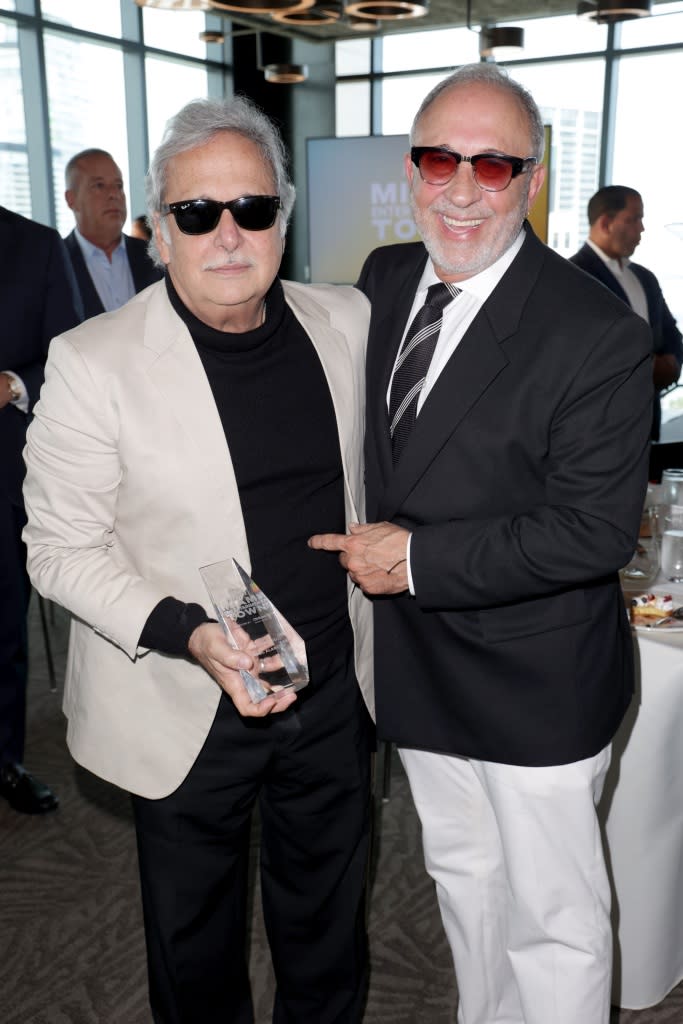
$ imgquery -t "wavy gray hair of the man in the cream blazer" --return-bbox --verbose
[144,96,296,266]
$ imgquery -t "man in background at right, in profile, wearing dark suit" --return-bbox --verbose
[569,185,683,441]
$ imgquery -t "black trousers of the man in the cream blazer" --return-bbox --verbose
[133,655,371,1024]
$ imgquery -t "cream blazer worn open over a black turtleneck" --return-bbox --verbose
[24,282,373,799]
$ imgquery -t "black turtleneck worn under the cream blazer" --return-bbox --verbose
[140,275,351,682]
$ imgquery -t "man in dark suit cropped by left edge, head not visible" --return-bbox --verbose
[0,207,82,814]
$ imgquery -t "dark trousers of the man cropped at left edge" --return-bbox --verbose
[0,494,31,764]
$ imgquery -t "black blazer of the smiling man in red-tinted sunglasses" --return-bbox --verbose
[358,226,651,765]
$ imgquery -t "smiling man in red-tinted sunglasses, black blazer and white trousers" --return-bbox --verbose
[309,63,651,1024]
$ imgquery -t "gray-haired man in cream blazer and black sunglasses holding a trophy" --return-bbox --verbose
[25,99,371,1024]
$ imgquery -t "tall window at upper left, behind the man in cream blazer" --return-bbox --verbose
[0,0,229,234]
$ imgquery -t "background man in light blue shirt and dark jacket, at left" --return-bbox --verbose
[65,150,163,319]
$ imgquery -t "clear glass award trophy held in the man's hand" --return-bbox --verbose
[200,558,308,703]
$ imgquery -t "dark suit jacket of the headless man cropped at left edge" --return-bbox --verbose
[0,207,83,506]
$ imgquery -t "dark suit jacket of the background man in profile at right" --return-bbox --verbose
[569,243,683,440]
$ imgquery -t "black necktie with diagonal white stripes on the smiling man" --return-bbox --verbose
[389,282,460,466]
